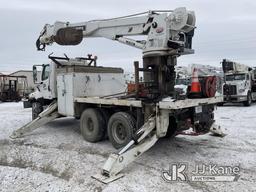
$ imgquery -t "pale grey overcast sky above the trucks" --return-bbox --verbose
[0,0,256,71]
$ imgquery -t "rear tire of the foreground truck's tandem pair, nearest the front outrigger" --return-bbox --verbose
[108,112,136,149]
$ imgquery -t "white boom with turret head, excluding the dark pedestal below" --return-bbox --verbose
[37,8,195,55]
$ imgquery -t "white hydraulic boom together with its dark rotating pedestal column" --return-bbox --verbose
[36,8,196,100]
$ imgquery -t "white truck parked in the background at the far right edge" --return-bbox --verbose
[222,59,256,106]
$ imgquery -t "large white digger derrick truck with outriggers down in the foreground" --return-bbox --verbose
[11,8,223,183]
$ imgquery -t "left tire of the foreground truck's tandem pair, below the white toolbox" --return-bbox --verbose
[80,108,106,143]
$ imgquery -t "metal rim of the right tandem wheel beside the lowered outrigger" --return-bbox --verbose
[112,122,127,144]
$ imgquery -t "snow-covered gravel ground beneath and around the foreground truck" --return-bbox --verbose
[0,103,256,192]
